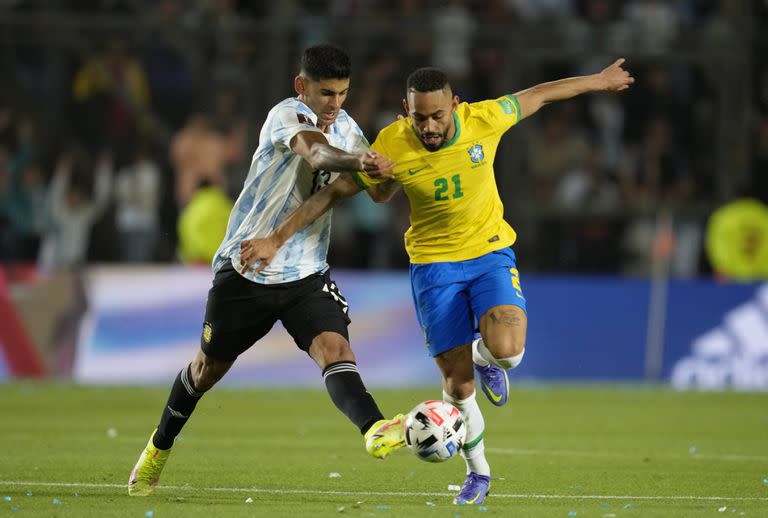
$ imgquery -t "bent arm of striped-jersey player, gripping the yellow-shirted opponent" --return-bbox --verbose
[291,131,395,179]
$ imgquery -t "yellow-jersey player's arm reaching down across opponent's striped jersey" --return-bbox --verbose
[240,175,360,274]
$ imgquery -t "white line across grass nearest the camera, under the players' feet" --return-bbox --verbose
[0,480,768,502]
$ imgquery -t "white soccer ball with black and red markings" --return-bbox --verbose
[405,400,467,462]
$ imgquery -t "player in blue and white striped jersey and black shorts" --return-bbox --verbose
[128,45,404,496]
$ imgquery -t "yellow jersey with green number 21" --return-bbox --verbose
[355,95,520,264]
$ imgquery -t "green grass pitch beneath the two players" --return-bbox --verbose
[0,382,768,518]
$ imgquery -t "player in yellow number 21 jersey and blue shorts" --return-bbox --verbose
[242,59,634,504]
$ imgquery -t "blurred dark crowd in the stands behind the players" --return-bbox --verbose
[0,0,768,277]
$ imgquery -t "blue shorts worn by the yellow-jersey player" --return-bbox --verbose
[411,248,527,356]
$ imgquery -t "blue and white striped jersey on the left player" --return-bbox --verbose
[213,97,368,284]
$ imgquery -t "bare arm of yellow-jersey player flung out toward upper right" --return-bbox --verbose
[515,58,635,119]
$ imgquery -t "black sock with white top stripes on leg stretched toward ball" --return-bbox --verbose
[323,361,384,434]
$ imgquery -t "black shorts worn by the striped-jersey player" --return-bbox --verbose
[200,265,350,361]
